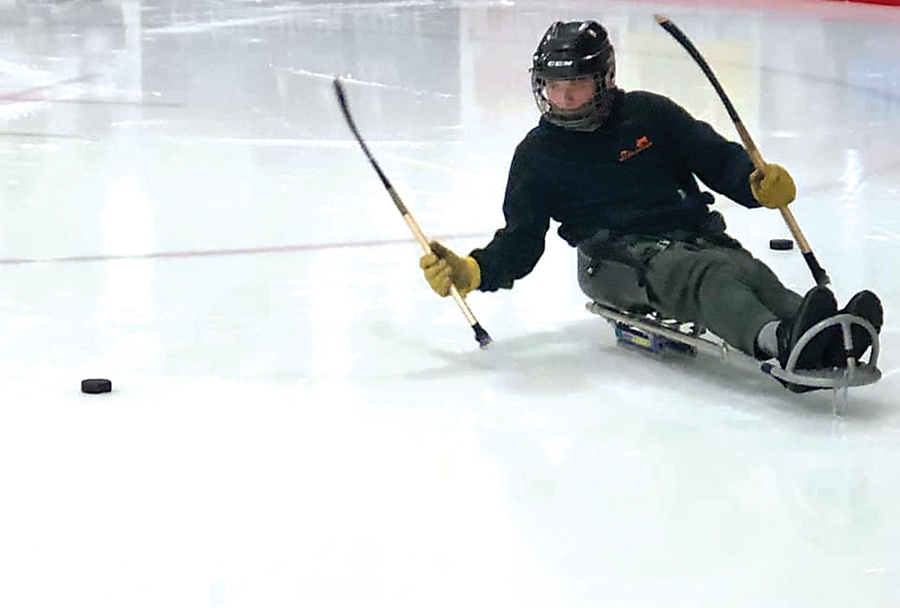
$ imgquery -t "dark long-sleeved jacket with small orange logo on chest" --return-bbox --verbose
[470,91,760,291]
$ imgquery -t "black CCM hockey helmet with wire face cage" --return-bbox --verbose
[531,21,616,131]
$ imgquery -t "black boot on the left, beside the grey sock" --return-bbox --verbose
[775,285,840,370]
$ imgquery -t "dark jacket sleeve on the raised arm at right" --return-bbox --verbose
[665,100,760,209]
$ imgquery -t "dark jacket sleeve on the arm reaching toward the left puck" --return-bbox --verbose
[469,144,550,291]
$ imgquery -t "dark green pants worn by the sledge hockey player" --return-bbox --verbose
[578,235,803,356]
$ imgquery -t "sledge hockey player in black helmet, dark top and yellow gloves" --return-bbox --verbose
[420,21,883,392]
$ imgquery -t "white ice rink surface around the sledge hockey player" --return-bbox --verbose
[0,0,900,608]
